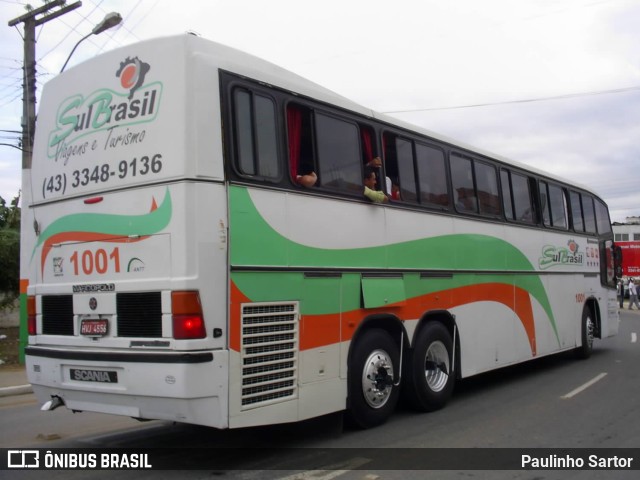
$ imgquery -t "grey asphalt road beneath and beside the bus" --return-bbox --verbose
[0,311,640,480]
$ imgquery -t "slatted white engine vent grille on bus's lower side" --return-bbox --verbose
[241,302,299,409]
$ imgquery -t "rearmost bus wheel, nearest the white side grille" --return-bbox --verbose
[347,329,400,428]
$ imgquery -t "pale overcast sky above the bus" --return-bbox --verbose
[0,0,640,222]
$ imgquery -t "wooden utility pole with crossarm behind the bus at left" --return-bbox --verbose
[9,0,82,170]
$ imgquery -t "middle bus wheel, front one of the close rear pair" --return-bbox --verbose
[405,322,456,412]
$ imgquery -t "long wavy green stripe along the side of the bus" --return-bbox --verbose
[229,186,559,341]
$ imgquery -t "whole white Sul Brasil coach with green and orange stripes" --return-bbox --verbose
[21,35,619,428]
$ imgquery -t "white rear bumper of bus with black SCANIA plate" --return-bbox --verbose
[25,346,229,428]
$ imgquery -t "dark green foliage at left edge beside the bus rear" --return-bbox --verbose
[0,195,20,308]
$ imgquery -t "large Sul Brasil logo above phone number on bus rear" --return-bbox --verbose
[47,57,162,160]
